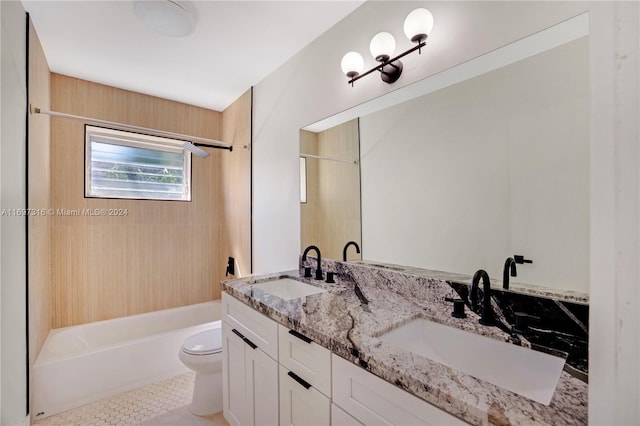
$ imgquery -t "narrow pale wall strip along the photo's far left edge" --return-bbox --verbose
[0,1,27,425]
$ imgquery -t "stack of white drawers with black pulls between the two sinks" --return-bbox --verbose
[278,325,331,426]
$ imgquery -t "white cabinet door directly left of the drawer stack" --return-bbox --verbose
[243,345,278,426]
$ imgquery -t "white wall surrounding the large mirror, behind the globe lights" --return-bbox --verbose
[253,2,640,424]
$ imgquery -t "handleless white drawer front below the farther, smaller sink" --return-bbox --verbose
[222,293,278,360]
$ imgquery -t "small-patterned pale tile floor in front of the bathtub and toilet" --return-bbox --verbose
[33,373,227,426]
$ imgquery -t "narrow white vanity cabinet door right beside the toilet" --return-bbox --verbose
[222,321,253,425]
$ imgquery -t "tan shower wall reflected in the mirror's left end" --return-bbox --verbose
[300,119,361,260]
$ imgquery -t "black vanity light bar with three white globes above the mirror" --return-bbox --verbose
[340,8,433,86]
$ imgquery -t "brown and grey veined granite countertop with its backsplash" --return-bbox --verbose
[222,262,587,425]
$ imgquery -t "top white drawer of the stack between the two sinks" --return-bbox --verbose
[278,325,331,397]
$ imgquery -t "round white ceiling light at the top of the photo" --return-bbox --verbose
[133,0,196,37]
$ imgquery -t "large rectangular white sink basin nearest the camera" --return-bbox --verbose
[380,319,565,405]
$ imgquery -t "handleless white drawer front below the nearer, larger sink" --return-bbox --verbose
[332,355,467,425]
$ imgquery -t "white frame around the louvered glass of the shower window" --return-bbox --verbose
[84,124,192,202]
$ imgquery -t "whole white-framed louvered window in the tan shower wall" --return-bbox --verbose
[85,125,191,201]
